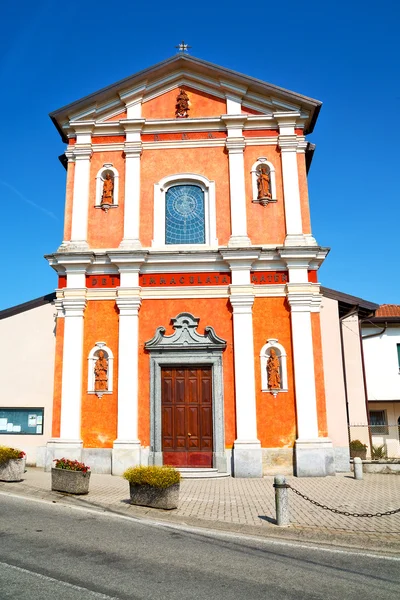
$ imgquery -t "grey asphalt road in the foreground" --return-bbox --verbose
[0,495,400,600]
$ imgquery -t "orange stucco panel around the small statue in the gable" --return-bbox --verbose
[142,86,226,119]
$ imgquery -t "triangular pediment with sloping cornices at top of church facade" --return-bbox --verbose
[50,54,321,139]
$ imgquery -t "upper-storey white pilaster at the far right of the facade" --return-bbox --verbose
[274,113,316,246]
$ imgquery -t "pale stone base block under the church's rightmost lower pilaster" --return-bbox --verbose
[295,438,335,477]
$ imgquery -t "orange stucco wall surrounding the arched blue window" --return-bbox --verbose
[140,147,230,246]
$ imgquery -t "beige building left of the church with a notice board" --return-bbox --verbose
[0,294,55,466]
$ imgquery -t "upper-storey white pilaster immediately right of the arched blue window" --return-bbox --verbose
[222,115,251,247]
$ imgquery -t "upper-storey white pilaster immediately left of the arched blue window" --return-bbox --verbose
[120,119,145,249]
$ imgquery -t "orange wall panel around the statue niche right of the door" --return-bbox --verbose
[253,298,296,448]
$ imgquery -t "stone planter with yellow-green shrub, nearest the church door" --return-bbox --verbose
[123,467,181,510]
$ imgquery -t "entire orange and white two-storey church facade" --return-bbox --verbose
[46,54,335,477]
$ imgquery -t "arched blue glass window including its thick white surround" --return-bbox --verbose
[152,173,218,249]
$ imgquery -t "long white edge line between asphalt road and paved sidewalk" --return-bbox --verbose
[0,492,400,562]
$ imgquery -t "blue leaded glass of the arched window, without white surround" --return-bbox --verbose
[165,185,206,244]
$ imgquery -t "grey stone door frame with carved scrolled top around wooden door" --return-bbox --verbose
[145,313,228,473]
